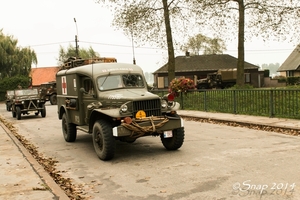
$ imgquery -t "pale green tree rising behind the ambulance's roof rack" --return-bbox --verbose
[57,44,100,65]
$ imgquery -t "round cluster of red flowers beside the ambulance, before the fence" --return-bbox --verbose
[169,77,195,97]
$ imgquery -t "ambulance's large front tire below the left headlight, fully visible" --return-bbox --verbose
[93,120,116,160]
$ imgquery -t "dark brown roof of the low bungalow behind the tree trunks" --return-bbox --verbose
[154,54,259,74]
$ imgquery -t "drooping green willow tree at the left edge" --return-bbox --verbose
[0,29,37,78]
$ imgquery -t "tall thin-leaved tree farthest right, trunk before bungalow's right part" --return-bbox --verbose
[190,0,300,86]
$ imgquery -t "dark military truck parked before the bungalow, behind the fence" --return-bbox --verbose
[197,68,237,89]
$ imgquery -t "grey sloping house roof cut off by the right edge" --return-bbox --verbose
[277,45,300,72]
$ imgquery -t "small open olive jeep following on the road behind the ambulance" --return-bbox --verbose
[12,88,46,120]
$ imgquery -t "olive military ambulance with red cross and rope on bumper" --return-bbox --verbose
[56,58,184,160]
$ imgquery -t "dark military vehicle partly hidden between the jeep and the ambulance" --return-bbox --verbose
[40,81,57,105]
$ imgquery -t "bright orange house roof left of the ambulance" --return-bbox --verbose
[31,67,59,86]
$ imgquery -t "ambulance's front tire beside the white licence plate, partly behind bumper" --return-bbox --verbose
[160,127,184,150]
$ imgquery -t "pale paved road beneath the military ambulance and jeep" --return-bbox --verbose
[0,105,300,200]
